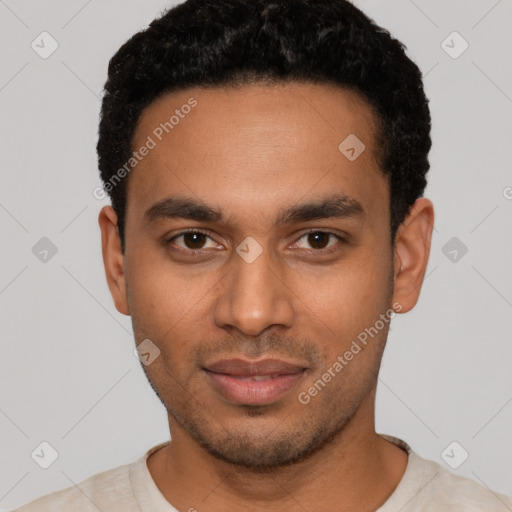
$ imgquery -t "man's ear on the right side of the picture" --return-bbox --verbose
[393,197,434,313]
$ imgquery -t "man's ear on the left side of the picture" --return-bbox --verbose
[98,206,130,315]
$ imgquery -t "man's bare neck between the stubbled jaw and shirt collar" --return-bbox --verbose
[147,392,407,512]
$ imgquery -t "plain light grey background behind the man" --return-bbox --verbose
[0,0,512,510]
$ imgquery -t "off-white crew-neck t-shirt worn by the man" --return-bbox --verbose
[13,434,512,512]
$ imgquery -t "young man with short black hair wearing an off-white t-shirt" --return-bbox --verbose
[15,0,512,512]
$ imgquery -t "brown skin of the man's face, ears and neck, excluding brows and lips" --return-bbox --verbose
[99,83,434,512]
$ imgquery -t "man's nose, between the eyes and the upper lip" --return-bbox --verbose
[214,244,295,336]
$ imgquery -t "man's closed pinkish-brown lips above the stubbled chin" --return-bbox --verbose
[204,359,307,405]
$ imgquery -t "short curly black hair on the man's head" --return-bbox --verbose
[97,0,431,250]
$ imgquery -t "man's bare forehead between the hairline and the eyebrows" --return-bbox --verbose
[128,83,388,226]
